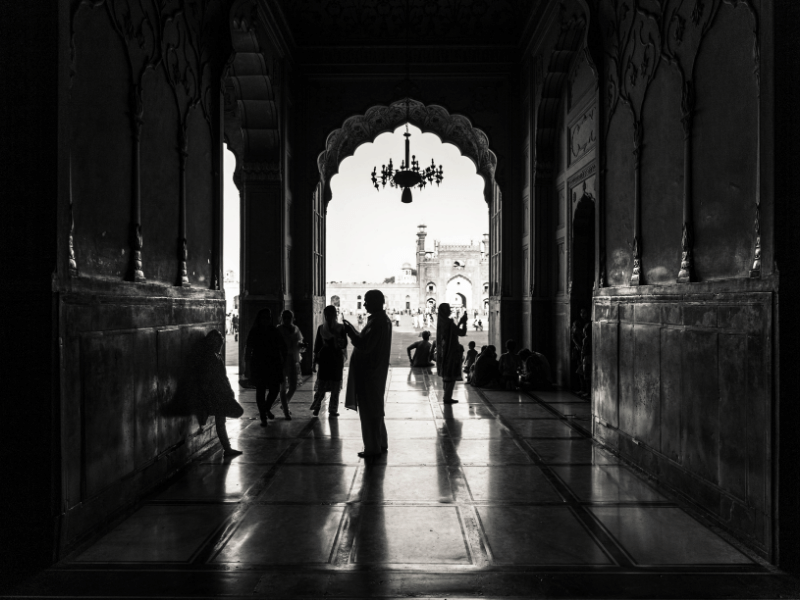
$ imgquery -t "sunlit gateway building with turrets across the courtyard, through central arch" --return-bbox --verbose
[326,225,489,315]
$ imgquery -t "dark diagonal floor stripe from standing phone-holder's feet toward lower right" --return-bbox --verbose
[468,388,633,567]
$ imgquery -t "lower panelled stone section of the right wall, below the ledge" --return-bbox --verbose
[593,286,773,555]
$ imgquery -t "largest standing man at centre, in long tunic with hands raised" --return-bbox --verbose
[344,290,392,457]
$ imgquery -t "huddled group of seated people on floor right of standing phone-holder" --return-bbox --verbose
[464,340,553,391]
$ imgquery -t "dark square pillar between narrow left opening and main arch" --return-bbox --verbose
[239,162,284,368]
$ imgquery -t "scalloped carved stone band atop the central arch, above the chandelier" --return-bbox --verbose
[317,98,497,203]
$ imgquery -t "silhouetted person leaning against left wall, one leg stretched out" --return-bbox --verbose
[193,329,242,456]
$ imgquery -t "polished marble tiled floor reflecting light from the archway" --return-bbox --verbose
[12,334,796,598]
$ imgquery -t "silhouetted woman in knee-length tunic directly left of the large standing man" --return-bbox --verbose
[311,306,347,417]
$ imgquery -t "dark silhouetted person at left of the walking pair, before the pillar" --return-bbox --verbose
[244,308,288,427]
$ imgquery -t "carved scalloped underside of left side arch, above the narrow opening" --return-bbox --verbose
[223,0,280,189]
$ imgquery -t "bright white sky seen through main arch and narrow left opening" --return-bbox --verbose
[223,126,489,282]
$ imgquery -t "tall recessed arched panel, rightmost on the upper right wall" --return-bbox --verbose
[693,3,759,280]
